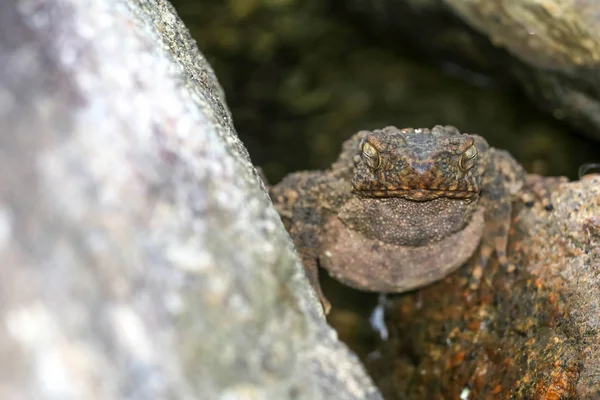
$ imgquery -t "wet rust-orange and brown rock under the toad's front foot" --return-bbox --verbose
[367,175,600,400]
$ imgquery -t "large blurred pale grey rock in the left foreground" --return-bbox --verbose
[0,0,380,400]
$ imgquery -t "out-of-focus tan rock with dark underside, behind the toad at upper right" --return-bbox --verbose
[344,0,600,144]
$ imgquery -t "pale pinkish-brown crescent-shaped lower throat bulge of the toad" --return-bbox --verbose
[319,209,484,293]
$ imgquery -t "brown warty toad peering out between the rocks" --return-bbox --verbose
[270,126,526,312]
